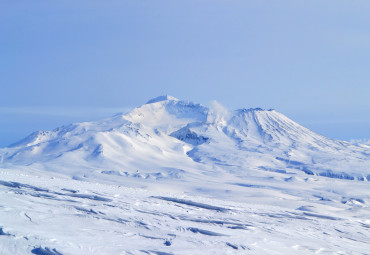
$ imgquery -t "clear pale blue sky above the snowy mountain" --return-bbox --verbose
[0,0,370,146]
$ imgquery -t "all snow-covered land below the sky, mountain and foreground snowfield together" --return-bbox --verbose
[0,96,370,255]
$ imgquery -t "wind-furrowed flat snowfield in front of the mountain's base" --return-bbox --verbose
[0,165,370,255]
